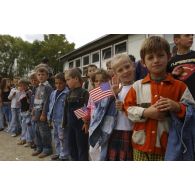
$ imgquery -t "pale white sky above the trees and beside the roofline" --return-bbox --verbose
[10,32,105,48]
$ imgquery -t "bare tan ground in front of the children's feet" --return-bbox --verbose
[0,131,50,161]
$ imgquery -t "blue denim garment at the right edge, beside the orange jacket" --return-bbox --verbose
[165,105,195,161]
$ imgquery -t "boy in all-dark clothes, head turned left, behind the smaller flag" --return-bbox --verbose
[62,69,89,160]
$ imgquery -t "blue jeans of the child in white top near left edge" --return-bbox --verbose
[10,108,21,134]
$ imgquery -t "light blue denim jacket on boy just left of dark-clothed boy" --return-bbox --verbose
[47,88,69,123]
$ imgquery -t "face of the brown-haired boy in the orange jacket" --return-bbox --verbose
[143,50,170,78]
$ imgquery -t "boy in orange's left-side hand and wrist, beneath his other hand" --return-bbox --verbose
[143,104,167,120]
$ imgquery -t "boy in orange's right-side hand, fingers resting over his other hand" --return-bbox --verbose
[156,97,180,112]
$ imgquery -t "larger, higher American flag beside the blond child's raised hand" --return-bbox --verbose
[89,82,114,102]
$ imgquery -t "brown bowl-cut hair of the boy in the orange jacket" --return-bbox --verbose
[140,36,170,60]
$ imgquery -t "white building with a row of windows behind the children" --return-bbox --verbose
[60,34,195,76]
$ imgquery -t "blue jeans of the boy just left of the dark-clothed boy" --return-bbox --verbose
[53,122,70,159]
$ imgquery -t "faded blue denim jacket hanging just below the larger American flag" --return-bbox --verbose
[89,97,117,147]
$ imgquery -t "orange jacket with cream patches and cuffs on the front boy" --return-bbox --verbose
[124,74,194,154]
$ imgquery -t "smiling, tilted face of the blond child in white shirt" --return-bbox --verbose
[115,61,135,85]
